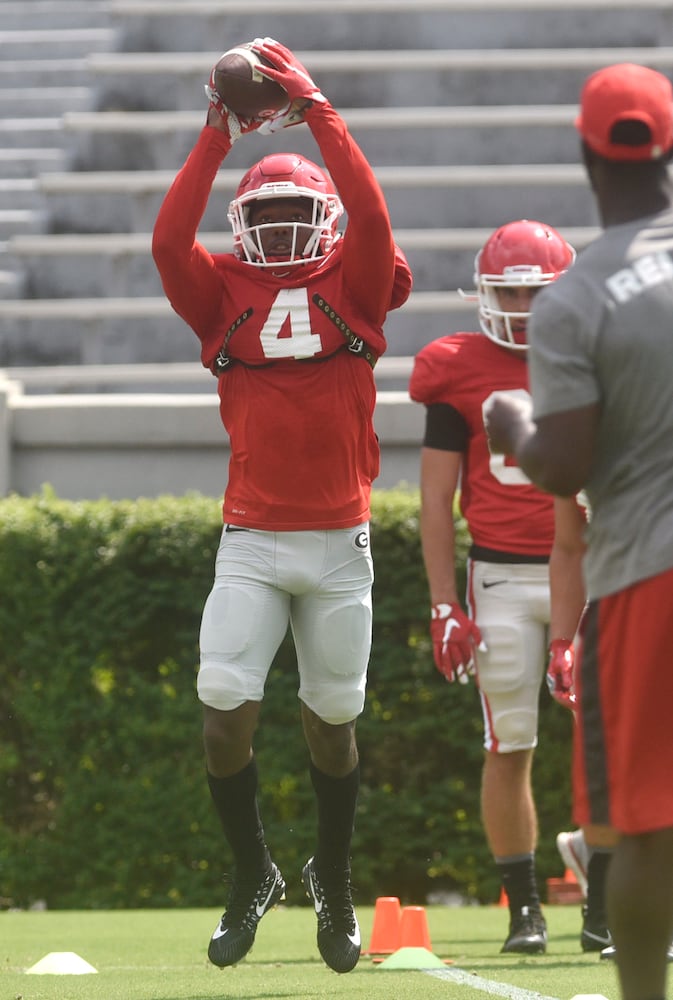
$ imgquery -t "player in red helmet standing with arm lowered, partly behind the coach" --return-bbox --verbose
[409,219,575,954]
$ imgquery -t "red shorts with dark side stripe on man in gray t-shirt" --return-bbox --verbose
[573,570,673,834]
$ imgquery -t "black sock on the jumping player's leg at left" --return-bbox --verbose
[207,757,271,872]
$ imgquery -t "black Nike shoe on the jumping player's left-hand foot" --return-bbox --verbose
[208,862,285,969]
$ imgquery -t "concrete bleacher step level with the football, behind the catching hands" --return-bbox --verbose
[89,46,673,111]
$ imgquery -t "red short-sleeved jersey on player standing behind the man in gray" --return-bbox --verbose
[409,333,554,556]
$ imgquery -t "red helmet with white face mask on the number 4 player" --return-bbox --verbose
[228,153,343,267]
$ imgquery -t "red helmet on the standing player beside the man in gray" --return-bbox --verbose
[474,219,575,350]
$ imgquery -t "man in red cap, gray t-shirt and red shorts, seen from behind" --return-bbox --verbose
[486,63,673,1000]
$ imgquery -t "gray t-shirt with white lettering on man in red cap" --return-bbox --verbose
[528,211,673,599]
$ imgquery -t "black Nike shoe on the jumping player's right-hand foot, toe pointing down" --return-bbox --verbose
[301,858,360,972]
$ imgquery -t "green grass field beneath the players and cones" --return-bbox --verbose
[0,906,636,1000]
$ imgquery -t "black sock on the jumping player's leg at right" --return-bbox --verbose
[310,761,360,881]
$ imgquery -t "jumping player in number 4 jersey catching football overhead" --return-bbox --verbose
[153,38,411,972]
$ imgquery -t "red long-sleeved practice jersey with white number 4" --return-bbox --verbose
[153,105,411,531]
